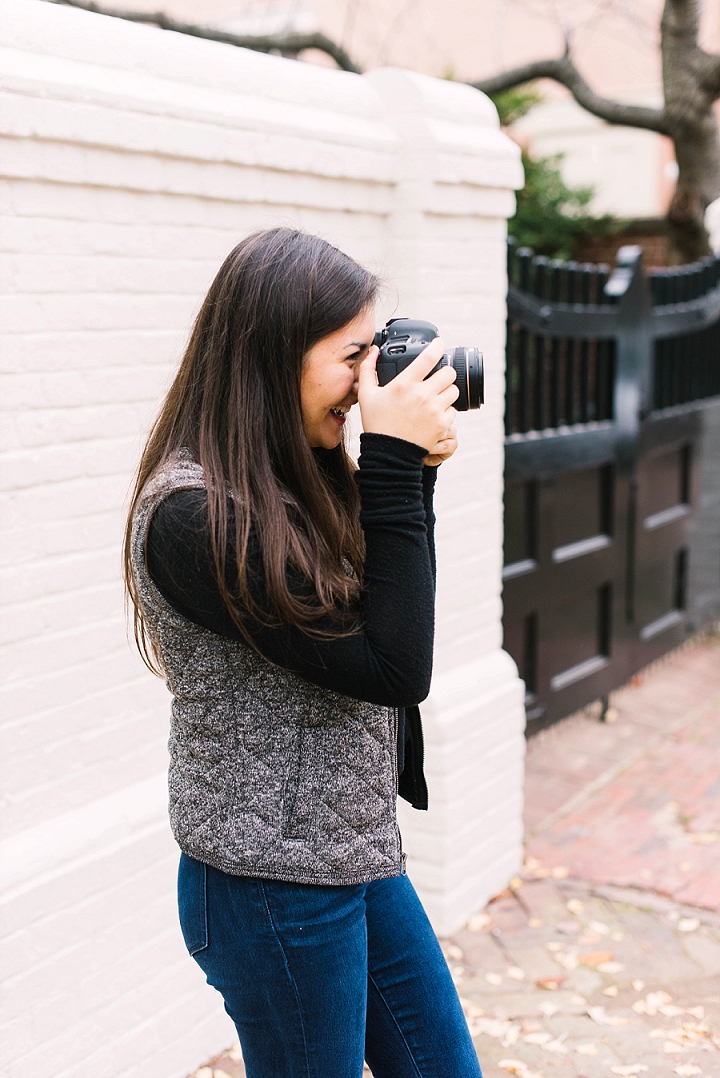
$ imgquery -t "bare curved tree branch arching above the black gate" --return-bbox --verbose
[470,54,668,135]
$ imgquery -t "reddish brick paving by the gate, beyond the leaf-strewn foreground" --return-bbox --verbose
[526,638,720,910]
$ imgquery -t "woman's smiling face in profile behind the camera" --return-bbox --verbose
[300,306,375,450]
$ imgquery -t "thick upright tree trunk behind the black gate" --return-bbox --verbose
[661,0,720,264]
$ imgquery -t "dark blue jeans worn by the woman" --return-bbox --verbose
[178,854,482,1078]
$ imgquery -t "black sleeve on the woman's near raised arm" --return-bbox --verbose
[148,434,434,707]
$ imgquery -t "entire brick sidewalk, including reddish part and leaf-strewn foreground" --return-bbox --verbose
[187,637,720,1078]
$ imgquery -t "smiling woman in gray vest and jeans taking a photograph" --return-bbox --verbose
[125,229,480,1078]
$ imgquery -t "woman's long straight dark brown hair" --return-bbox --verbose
[124,229,378,673]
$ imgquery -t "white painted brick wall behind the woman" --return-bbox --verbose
[0,0,523,1078]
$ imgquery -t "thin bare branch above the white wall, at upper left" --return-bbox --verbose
[50,0,361,74]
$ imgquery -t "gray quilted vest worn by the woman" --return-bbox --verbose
[131,453,402,884]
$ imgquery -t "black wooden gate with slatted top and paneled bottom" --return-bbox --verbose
[503,243,720,733]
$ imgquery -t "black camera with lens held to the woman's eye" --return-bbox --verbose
[373,318,485,412]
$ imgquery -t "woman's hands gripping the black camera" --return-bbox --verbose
[358,337,459,452]
